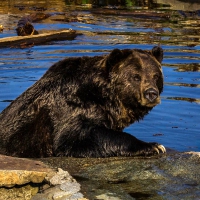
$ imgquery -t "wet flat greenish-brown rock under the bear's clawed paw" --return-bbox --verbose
[40,152,200,200]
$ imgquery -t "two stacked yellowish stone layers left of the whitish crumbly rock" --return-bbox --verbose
[0,155,52,200]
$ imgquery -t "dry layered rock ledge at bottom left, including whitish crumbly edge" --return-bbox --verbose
[0,155,87,200]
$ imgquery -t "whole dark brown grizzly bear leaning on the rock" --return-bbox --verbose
[0,47,166,157]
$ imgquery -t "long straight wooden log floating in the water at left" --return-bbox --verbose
[0,30,80,48]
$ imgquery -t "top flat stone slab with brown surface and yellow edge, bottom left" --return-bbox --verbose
[0,155,53,187]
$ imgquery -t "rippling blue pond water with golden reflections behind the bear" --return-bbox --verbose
[0,0,200,151]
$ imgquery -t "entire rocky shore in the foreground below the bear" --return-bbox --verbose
[0,152,200,200]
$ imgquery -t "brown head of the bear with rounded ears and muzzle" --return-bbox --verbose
[105,46,163,109]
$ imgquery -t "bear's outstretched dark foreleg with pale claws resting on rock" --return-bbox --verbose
[55,127,166,157]
